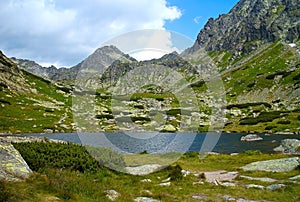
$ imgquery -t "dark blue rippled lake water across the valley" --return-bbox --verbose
[22,133,300,153]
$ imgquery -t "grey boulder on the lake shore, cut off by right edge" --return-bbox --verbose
[274,139,300,155]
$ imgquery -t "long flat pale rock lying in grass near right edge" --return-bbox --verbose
[242,157,299,172]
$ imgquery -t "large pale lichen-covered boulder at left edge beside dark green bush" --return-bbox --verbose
[0,140,32,181]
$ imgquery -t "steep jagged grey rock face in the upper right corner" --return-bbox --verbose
[186,0,300,53]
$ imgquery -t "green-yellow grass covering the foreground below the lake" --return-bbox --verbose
[0,143,300,201]
